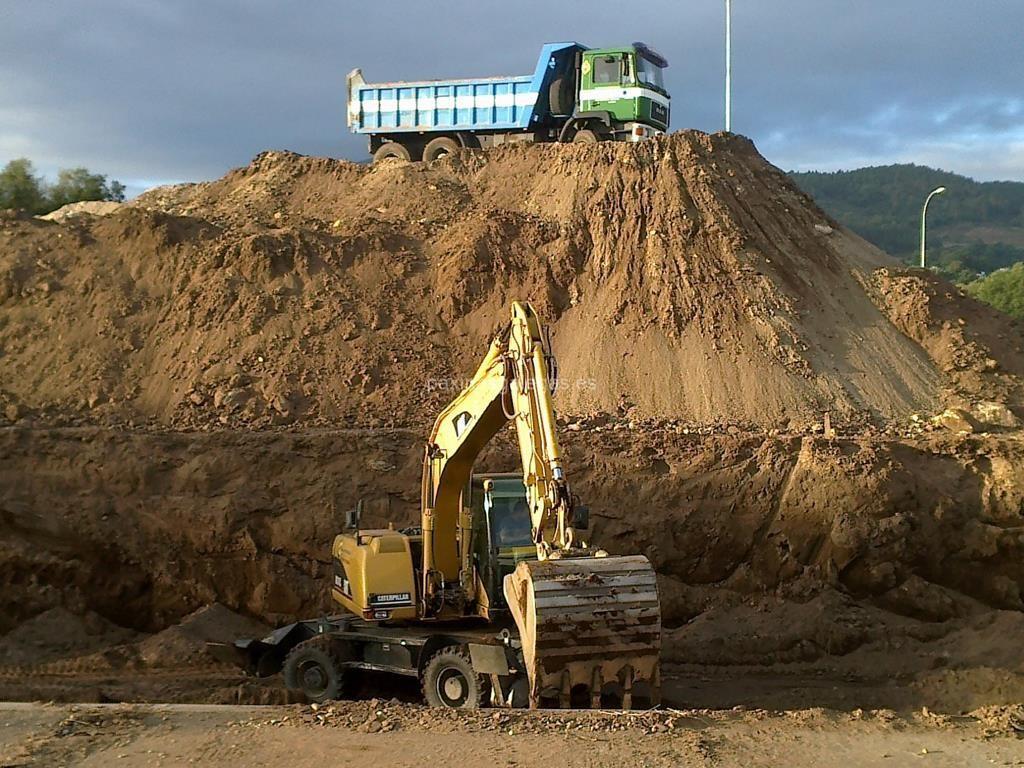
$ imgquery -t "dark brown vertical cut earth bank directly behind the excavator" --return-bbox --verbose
[0,428,1024,647]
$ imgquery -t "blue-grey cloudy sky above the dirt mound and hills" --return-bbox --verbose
[0,0,1024,194]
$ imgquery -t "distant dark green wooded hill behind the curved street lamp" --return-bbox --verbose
[790,165,1024,282]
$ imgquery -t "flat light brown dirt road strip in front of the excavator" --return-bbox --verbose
[0,702,1024,768]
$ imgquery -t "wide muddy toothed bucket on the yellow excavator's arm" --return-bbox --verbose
[505,555,662,710]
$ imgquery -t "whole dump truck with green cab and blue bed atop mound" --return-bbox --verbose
[347,42,670,163]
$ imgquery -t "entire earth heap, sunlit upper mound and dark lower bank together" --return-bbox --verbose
[0,132,1024,707]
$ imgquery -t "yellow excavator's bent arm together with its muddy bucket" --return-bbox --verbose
[421,302,660,708]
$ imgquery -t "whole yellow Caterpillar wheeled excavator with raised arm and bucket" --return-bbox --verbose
[213,302,662,709]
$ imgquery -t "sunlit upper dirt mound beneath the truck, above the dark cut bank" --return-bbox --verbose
[0,132,1024,428]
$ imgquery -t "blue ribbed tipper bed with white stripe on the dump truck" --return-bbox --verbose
[348,42,585,133]
